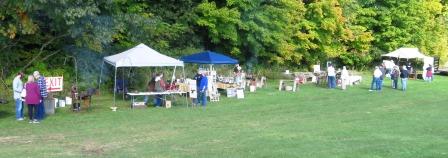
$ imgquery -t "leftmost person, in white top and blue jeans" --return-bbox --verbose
[12,72,24,121]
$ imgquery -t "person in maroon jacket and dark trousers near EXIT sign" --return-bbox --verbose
[25,75,42,123]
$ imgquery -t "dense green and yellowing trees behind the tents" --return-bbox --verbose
[0,0,448,81]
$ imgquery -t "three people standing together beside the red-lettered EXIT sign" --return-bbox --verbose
[13,71,48,123]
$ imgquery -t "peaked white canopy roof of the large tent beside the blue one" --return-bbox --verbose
[104,43,184,67]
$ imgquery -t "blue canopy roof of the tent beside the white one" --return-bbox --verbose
[180,51,238,64]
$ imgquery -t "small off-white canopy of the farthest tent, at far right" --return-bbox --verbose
[381,48,434,78]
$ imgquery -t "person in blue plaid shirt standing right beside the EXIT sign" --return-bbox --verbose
[33,71,48,120]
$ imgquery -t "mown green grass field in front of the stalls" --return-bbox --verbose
[0,76,448,158]
